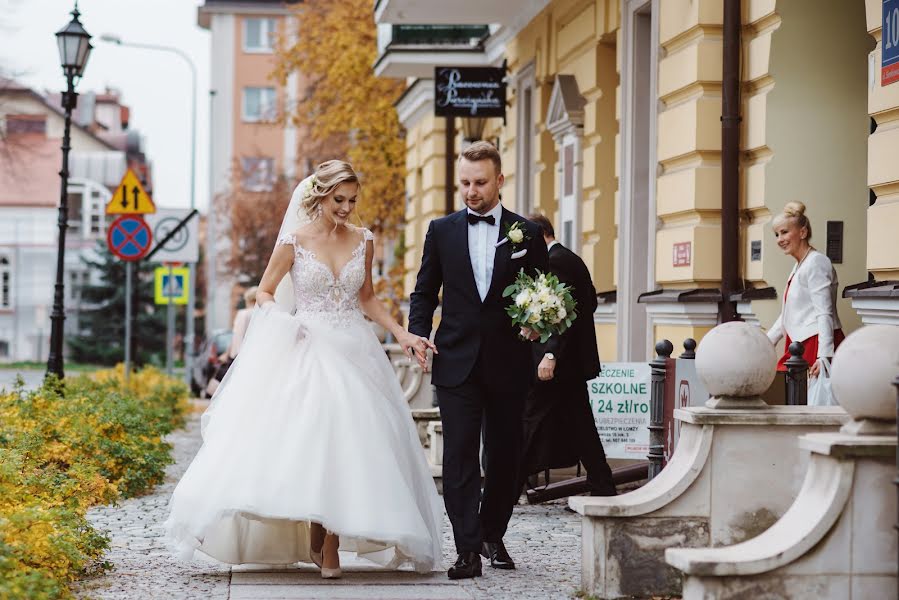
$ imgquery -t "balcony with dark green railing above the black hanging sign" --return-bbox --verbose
[374,23,490,79]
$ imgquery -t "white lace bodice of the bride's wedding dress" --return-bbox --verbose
[278,229,374,324]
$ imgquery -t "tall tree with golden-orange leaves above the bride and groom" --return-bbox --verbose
[274,0,406,232]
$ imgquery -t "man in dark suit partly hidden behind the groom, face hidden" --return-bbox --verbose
[521,214,615,496]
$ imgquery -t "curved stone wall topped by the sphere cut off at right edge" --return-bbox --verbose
[666,325,899,600]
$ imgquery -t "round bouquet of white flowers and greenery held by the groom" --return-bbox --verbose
[503,269,577,344]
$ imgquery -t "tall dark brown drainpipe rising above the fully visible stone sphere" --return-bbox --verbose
[718,0,743,323]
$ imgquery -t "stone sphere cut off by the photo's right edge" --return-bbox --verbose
[830,325,899,421]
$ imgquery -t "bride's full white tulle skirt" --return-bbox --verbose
[166,309,442,572]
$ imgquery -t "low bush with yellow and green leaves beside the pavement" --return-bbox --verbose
[0,366,188,600]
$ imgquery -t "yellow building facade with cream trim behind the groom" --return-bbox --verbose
[375,0,899,361]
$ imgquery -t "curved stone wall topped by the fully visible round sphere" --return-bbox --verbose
[569,322,847,598]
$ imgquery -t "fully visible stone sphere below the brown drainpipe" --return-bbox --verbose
[696,321,777,397]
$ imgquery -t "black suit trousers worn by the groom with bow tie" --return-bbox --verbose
[437,356,530,552]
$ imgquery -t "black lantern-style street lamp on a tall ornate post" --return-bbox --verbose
[47,1,92,379]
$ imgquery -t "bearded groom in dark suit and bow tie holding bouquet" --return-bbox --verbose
[409,141,549,579]
